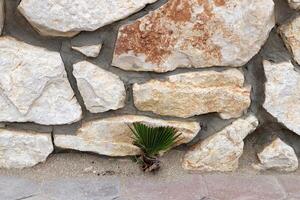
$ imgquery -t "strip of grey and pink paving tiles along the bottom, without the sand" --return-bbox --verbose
[0,174,300,200]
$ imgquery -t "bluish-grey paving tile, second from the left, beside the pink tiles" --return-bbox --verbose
[42,178,120,200]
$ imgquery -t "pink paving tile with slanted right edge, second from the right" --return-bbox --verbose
[204,174,286,200]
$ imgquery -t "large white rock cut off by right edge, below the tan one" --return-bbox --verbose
[263,61,300,135]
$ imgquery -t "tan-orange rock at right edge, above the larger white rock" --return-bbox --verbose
[279,16,300,64]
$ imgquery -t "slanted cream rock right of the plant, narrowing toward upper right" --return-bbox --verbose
[183,116,258,172]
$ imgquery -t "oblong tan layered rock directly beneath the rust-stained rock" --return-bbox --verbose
[133,69,251,119]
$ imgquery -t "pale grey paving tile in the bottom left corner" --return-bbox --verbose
[0,176,40,200]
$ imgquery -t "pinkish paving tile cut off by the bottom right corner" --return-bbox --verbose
[277,175,300,200]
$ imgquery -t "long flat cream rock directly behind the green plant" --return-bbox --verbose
[54,115,200,156]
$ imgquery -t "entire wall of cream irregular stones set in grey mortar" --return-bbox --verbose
[0,0,300,171]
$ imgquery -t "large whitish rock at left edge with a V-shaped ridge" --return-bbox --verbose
[0,37,81,125]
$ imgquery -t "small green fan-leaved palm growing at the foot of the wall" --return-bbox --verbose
[130,123,181,172]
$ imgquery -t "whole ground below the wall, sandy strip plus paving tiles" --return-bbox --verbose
[0,151,300,200]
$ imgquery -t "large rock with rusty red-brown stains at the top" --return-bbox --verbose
[113,0,275,72]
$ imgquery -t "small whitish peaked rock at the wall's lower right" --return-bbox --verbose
[254,138,298,172]
